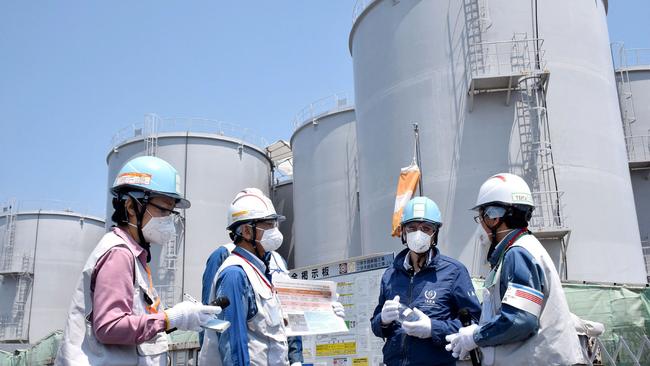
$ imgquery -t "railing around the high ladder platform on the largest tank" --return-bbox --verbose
[469,38,546,78]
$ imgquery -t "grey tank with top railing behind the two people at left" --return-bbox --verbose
[106,116,271,304]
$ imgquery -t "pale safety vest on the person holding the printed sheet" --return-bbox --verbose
[199,249,289,366]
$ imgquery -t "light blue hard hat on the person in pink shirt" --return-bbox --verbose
[111,156,190,208]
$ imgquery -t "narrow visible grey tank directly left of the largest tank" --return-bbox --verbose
[291,104,361,267]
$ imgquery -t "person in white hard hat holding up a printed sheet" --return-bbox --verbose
[199,188,344,366]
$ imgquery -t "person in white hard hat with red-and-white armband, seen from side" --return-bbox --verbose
[446,173,587,365]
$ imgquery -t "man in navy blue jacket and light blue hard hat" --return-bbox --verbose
[370,197,481,366]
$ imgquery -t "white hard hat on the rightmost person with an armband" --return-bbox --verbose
[472,173,535,210]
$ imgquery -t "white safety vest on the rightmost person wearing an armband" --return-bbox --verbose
[479,235,587,366]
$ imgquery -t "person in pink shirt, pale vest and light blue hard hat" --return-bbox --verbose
[55,156,221,365]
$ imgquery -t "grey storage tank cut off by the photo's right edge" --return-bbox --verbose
[614,46,650,278]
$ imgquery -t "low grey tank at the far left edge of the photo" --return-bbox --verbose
[0,209,105,343]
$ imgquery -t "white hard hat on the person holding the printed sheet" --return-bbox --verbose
[228,188,284,229]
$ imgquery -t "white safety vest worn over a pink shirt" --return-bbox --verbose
[54,231,168,366]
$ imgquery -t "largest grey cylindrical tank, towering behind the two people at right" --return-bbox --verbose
[349,0,645,283]
